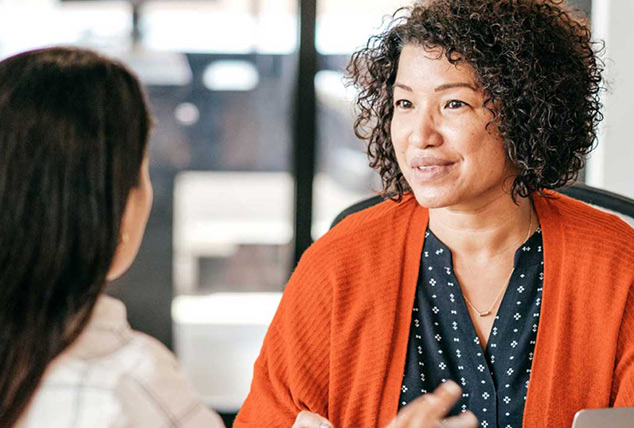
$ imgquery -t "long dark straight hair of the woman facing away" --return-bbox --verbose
[0,48,150,428]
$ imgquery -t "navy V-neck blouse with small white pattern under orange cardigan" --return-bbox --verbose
[399,229,544,428]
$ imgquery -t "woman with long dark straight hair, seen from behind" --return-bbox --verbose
[0,48,222,428]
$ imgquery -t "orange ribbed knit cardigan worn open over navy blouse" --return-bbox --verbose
[234,194,634,428]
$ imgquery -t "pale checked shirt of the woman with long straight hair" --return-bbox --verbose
[17,295,224,428]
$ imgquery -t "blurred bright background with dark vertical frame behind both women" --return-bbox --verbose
[0,0,634,424]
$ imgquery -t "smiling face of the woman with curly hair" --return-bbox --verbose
[391,44,516,208]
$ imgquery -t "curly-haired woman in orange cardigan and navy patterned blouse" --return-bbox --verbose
[236,0,634,428]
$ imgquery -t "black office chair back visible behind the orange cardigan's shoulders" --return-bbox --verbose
[330,183,634,229]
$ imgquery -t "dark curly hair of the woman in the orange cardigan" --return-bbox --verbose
[347,0,604,200]
